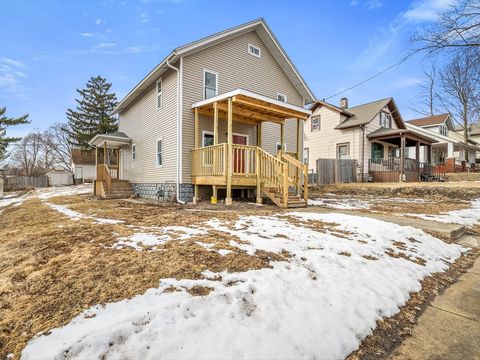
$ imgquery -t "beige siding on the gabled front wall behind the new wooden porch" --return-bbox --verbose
[182,31,303,182]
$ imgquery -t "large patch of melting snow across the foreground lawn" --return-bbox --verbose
[22,212,465,359]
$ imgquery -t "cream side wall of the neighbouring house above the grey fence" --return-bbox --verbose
[304,107,361,171]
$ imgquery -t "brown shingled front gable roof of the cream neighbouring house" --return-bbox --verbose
[335,97,405,129]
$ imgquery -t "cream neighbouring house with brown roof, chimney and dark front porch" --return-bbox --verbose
[304,97,435,181]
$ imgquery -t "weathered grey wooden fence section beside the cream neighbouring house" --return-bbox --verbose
[316,159,358,185]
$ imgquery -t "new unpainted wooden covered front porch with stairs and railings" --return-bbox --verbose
[191,89,310,207]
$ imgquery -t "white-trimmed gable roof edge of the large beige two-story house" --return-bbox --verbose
[113,18,315,113]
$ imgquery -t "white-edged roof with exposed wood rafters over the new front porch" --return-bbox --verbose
[192,89,312,124]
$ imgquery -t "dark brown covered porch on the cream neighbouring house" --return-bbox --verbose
[367,128,439,182]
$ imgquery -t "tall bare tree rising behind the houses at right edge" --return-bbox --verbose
[439,49,480,143]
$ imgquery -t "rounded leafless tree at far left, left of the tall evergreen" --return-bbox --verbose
[10,132,55,176]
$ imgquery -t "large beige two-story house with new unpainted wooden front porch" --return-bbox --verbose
[90,19,314,206]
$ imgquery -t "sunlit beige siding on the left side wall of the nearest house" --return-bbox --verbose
[119,70,177,183]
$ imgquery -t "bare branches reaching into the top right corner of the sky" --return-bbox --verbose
[414,0,480,54]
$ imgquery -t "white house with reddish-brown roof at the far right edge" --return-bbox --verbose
[407,114,480,172]
